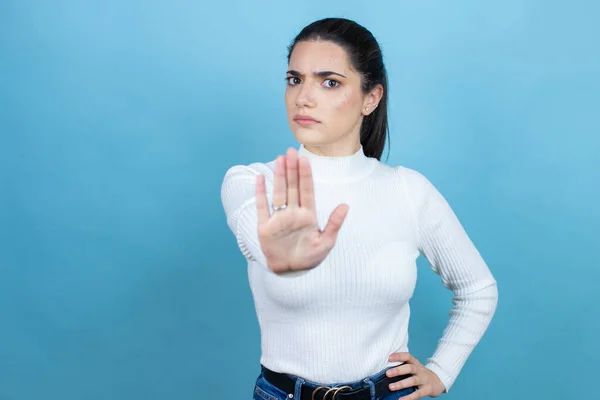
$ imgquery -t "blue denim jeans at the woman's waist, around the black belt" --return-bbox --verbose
[252,367,417,400]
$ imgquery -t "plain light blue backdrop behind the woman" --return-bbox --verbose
[0,0,600,400]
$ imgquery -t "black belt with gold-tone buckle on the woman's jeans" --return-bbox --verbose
[261,365,412,400]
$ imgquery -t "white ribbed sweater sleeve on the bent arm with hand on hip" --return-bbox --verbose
[406,170,498,392]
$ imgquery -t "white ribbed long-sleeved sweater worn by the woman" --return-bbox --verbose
[221,145,498,390]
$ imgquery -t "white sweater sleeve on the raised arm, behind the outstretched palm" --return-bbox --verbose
[221,165,270,266]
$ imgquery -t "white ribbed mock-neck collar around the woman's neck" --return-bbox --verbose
[298,144,375,183]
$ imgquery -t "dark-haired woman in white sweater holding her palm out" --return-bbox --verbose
[221,18,498,400]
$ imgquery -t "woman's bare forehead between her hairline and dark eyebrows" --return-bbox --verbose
[289,41,351,75]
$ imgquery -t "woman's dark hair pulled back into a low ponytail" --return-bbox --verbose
[287,18,389,160]
